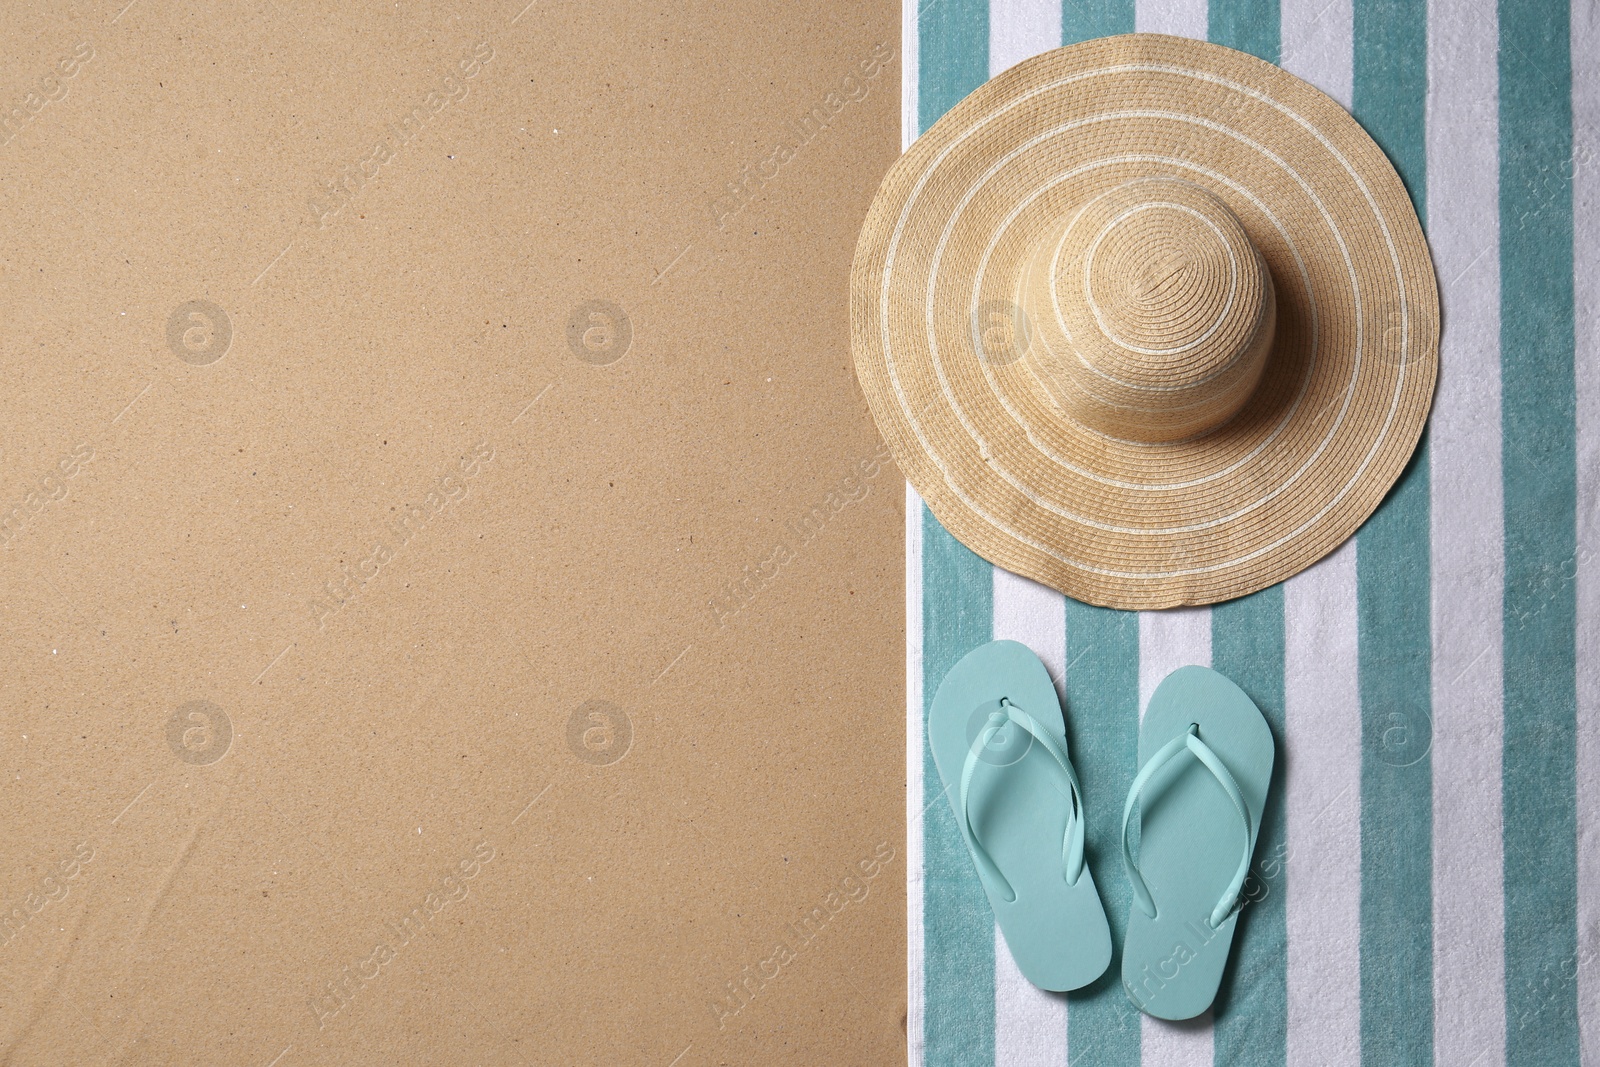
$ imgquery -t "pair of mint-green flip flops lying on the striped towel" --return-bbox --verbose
[928,641,1274,1019]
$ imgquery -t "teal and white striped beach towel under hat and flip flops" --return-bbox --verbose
[902,0,1600,1067]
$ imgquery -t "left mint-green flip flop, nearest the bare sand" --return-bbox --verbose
[928,641,1110,992]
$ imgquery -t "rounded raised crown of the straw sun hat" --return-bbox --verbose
[1018,178,1275,443]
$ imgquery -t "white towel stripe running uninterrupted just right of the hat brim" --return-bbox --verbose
[1426,0,1506,1067]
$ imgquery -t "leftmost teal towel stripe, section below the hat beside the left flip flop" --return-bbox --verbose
[922,506,995,1067]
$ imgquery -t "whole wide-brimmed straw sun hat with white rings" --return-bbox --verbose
[851,34,1438,608]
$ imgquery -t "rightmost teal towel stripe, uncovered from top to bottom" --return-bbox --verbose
[1499,0,1579,1067]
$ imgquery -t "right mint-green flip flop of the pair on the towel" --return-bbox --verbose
[1122,667,1272,1019]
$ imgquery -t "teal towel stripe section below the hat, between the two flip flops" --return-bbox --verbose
[1066,598,1139,1067]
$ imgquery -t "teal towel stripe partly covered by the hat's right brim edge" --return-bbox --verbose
[1352,0,1434,1067]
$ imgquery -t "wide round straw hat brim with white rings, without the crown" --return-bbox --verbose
[851,34,1438,608]
